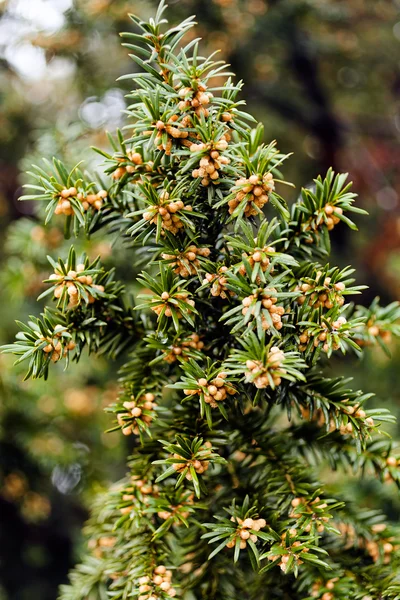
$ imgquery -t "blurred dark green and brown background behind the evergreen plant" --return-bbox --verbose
[0,0,400,600]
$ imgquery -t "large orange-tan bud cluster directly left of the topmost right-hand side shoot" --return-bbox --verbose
[228,173,275,217]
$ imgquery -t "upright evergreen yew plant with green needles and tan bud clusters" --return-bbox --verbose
[4,2,400,600]
